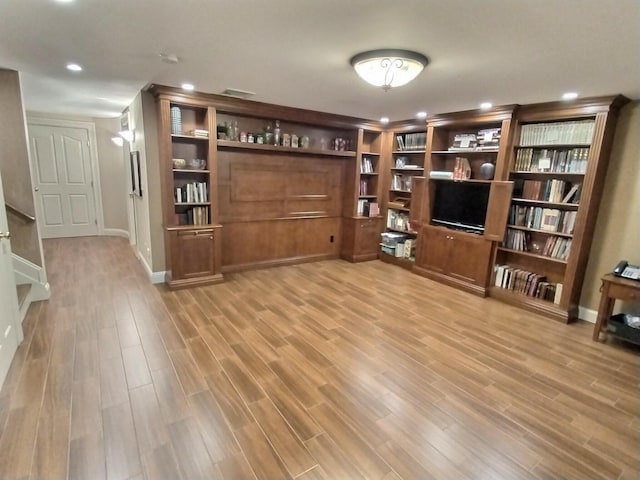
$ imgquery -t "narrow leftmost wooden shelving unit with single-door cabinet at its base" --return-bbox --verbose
[157,92,222,288]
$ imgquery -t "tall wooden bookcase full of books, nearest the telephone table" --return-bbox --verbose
[490,97,626,322]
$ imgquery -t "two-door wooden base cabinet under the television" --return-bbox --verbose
[413,226,492,296]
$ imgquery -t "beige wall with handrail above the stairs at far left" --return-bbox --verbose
[0,69,44,267]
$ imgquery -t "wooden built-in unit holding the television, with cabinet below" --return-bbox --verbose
[411,105,515,296]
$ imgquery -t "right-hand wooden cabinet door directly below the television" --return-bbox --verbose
[446,233,491,287]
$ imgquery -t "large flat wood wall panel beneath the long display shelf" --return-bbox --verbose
[218,150,344,271]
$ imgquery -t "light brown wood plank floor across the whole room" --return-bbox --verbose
[0,238,640,480]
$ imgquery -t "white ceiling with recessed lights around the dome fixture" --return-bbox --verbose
[0,0,640,121]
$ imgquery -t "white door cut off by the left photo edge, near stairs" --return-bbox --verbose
[0,171,22,388]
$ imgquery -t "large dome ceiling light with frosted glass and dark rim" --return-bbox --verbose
[351,49,429,91]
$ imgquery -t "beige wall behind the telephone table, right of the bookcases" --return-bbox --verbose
[580,101,640,310]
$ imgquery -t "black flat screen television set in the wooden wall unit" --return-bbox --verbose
[431,181,491,233]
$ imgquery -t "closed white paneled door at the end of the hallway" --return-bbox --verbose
[29,125,98,238]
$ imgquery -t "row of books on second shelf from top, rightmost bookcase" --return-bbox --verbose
[514,147,589,173]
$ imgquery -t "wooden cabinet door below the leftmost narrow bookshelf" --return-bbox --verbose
[172,229,215,280]
